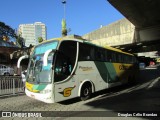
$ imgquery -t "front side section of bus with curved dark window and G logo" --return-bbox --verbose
[53,41,78,102]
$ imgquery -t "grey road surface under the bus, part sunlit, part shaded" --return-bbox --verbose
[0,67,160,120]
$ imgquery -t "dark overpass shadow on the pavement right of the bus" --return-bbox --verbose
[82,66,160,119]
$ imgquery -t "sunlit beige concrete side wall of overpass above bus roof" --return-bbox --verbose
[82,18,135,46]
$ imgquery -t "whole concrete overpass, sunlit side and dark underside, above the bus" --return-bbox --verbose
[83,0,160,58]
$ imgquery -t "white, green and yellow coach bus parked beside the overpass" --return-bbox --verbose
[18,38,137,103]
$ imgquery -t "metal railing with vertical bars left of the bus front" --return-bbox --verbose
[0,76,25,96]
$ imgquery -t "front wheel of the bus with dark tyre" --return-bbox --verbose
[80,84,92,101]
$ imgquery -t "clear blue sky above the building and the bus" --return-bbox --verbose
[0,0,124,39]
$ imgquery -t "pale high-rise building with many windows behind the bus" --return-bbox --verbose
[18,22,47,47]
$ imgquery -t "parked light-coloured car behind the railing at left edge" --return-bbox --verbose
[0,64,14,75]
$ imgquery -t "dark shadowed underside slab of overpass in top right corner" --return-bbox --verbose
[108,0,160,29]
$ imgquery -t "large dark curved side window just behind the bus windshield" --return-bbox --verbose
[54,41,77,82]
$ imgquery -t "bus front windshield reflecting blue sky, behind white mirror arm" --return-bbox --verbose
[27,41,58,84]
